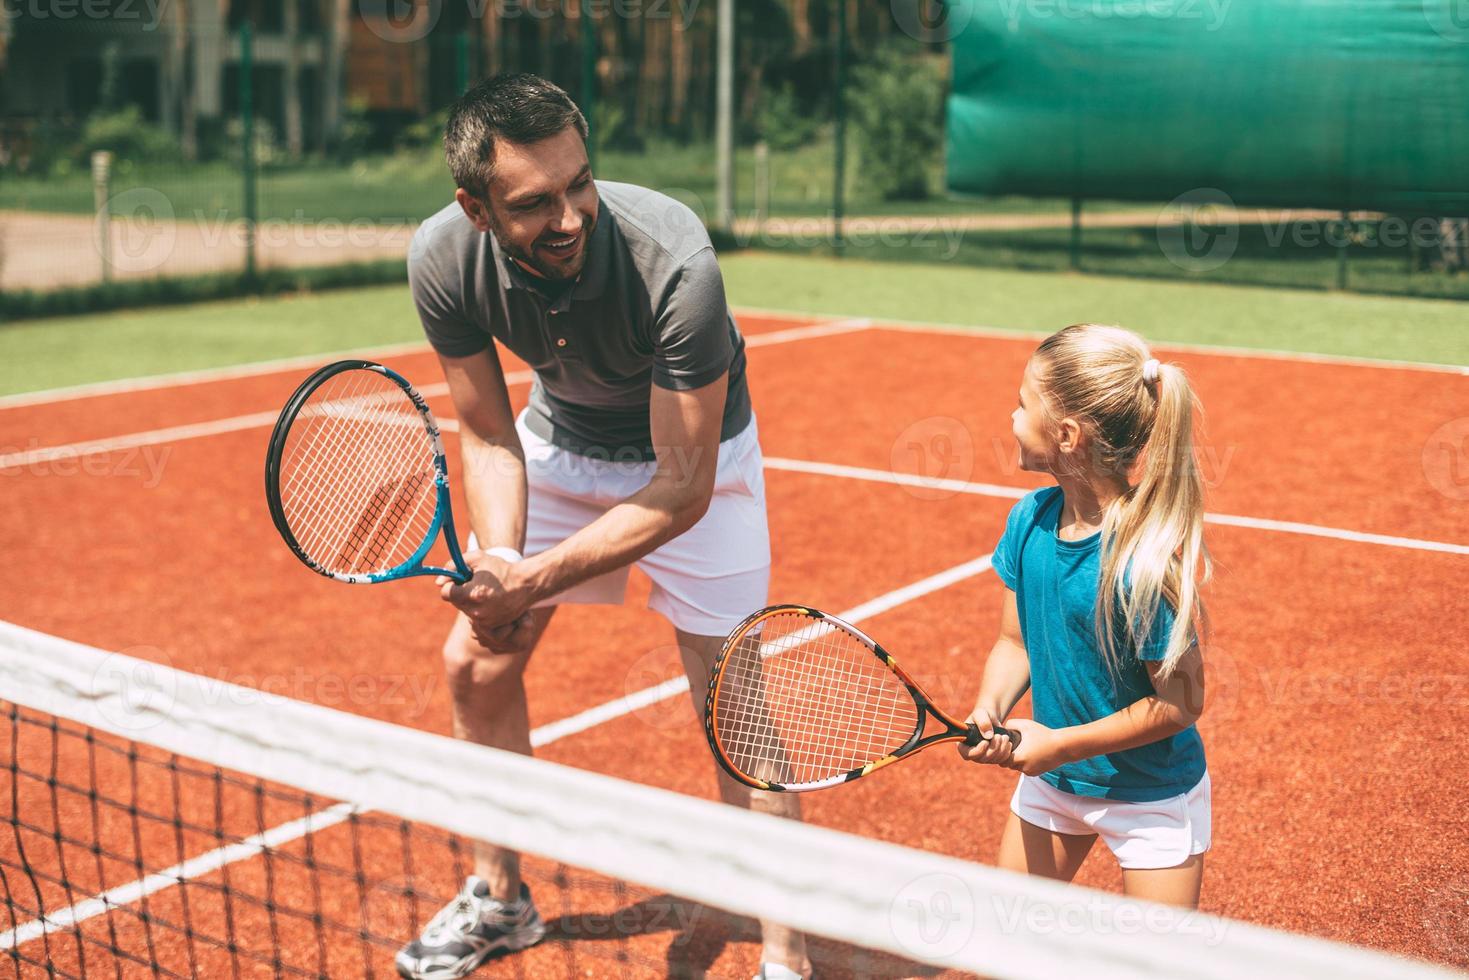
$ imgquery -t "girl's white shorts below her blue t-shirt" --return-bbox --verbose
[1011,773,1210,868]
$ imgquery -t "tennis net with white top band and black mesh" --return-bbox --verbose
[0,623,1445,980]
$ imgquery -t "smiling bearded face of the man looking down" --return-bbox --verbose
[455,126,598,281]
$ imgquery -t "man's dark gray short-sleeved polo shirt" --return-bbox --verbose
[408,181,751,460]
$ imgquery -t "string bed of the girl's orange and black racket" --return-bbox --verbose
[715,613,921,785]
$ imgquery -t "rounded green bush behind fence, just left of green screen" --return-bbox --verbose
[848,47,945,201]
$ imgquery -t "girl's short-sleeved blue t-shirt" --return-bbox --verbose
[995,486,1205,802]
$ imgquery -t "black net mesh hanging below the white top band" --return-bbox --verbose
[0,702,705,977]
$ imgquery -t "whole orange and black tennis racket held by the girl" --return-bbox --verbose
[704,605,1019,793]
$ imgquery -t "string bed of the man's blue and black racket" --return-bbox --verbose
[279,370,438,574]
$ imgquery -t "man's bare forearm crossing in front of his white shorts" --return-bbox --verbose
[516,473,710,602]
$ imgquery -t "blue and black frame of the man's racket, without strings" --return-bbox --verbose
[266,360,473,585]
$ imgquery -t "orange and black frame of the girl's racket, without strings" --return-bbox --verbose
[704,604,980,793]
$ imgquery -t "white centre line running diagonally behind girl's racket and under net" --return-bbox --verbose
[0,555,990,949]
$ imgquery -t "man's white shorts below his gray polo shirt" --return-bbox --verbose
[470,414,770,636]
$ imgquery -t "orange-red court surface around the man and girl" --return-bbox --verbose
[0,314,1469,977]
